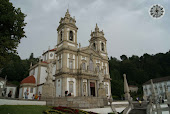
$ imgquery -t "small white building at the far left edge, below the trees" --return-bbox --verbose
[0,77,17,98]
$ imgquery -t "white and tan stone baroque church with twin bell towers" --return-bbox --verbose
[19,10,111,99]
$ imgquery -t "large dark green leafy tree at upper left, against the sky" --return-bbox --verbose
[0,0,26,70]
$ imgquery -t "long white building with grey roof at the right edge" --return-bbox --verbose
[143,76,170,98]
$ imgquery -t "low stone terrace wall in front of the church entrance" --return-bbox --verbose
[46,97,108,109]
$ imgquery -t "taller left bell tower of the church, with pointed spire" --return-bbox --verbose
[57,9,78,48]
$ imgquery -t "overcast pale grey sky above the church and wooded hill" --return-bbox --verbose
[11,0,170,59]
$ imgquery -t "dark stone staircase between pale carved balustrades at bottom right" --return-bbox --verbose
[129,102,147,114]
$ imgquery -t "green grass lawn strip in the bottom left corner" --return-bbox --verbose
[0,105,50,114]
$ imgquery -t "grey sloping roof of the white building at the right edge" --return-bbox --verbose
[143,76,170,85]
